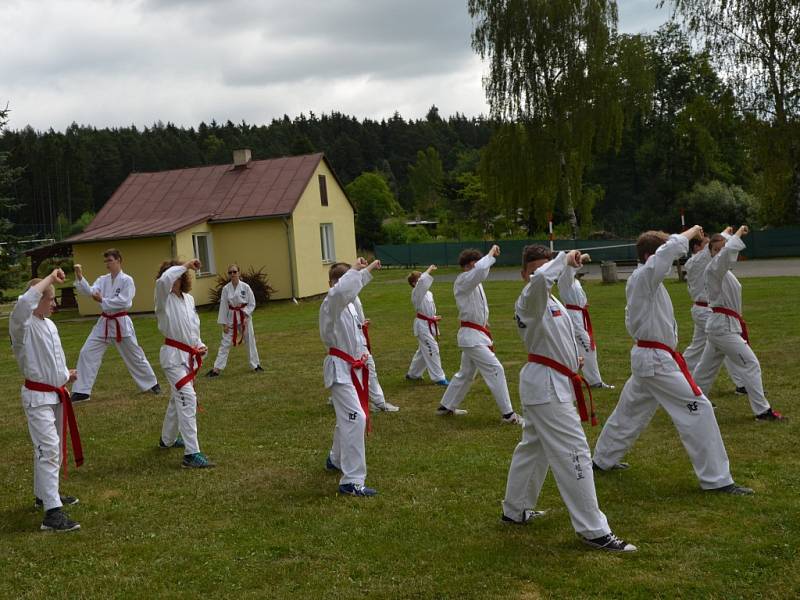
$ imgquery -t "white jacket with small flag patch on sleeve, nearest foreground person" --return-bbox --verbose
[514,252,579,404]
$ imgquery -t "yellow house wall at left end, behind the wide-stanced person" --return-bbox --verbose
[72,236,172,315]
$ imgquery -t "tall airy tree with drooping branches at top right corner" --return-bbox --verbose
[661,0,800,225]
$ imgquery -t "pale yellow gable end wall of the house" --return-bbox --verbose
[291,160,356,298]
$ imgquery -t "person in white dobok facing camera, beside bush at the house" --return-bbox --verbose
[206,264,264,377]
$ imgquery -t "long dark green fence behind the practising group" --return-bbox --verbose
[375,227,800,267]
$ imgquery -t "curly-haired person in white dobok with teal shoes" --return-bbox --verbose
[155,259,215,469]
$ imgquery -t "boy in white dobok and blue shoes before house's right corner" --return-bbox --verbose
[319,258,381,497]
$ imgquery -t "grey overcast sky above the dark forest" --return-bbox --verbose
[0,0,668,130]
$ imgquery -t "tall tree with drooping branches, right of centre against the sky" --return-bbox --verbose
[468,0,623,237]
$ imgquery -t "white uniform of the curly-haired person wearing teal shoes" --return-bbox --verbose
[155,265,203,455]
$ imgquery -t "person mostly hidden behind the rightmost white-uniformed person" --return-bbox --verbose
[683,227,746,394]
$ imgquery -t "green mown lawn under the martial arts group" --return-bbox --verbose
[0,270,800,598]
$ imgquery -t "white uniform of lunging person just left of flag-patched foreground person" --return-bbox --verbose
[441,254,514,415]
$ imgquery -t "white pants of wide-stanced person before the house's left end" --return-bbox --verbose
[72,335,158,395]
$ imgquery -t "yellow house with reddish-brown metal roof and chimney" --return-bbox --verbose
[64,150,356,315]
